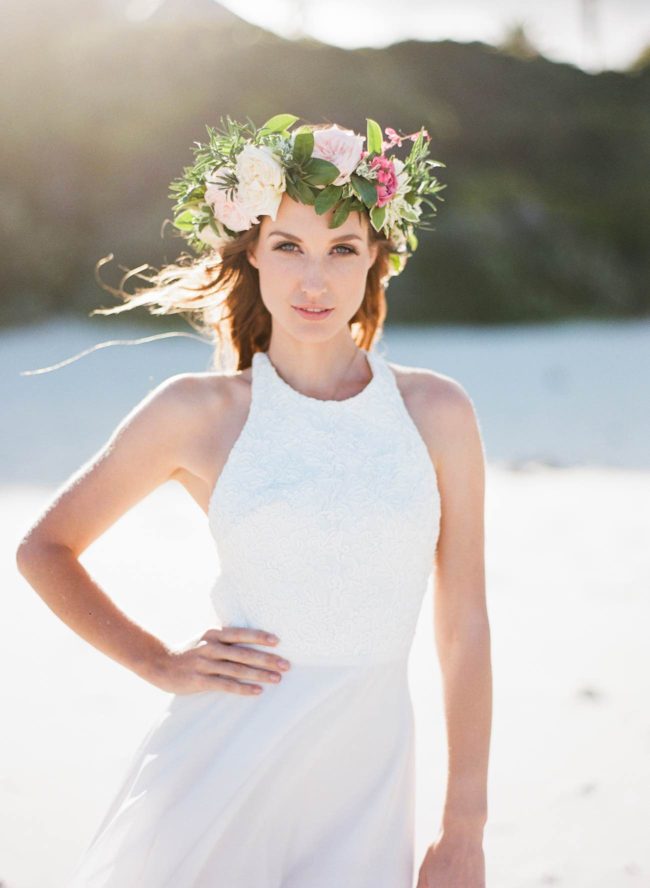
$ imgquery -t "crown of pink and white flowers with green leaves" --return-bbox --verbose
[169,114,446,274]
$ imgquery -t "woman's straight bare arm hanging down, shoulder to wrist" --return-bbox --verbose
[434,380,492,843]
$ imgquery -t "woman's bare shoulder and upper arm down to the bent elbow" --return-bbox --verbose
[13,366,251,555]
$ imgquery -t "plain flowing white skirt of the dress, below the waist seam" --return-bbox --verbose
[67,659,415,888]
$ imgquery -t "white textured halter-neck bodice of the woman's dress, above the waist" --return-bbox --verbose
[208,350,440,663]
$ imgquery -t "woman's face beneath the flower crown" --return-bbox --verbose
[247,193,377,340]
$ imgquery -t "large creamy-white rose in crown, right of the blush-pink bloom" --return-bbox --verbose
[235,145,286,221]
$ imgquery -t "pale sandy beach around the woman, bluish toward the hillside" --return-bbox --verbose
[0,322,650,888]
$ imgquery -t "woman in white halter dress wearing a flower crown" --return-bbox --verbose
[17,115,491,888]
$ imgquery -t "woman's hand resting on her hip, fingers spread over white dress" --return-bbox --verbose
[150,626,291,696]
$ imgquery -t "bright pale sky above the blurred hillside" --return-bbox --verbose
[208,0,650,71]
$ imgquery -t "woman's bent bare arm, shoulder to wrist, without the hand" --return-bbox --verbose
[16,376,196,680]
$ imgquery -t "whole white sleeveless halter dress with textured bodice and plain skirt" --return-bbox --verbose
[68,350,440,888]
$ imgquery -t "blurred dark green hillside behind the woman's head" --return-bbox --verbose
[0,7,650,324]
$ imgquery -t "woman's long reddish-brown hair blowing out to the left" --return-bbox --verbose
[91,213,395,372]
